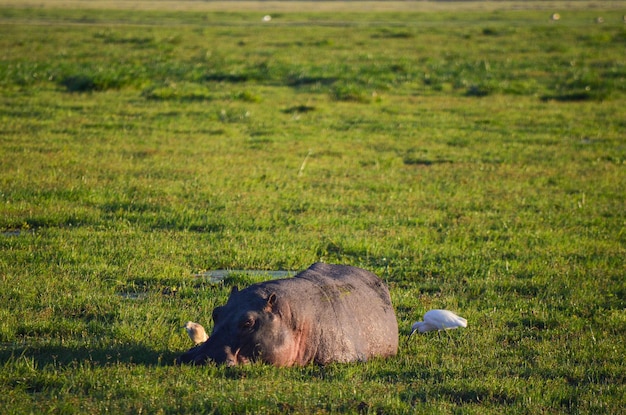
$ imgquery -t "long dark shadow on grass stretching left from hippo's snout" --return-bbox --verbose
[0,344,179,367]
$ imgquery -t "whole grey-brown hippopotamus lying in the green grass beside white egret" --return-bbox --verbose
[178,263,398,367]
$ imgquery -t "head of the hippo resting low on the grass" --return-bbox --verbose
[180,286,294,366]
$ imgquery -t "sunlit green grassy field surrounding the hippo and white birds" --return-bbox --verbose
[0,1,626,414]
